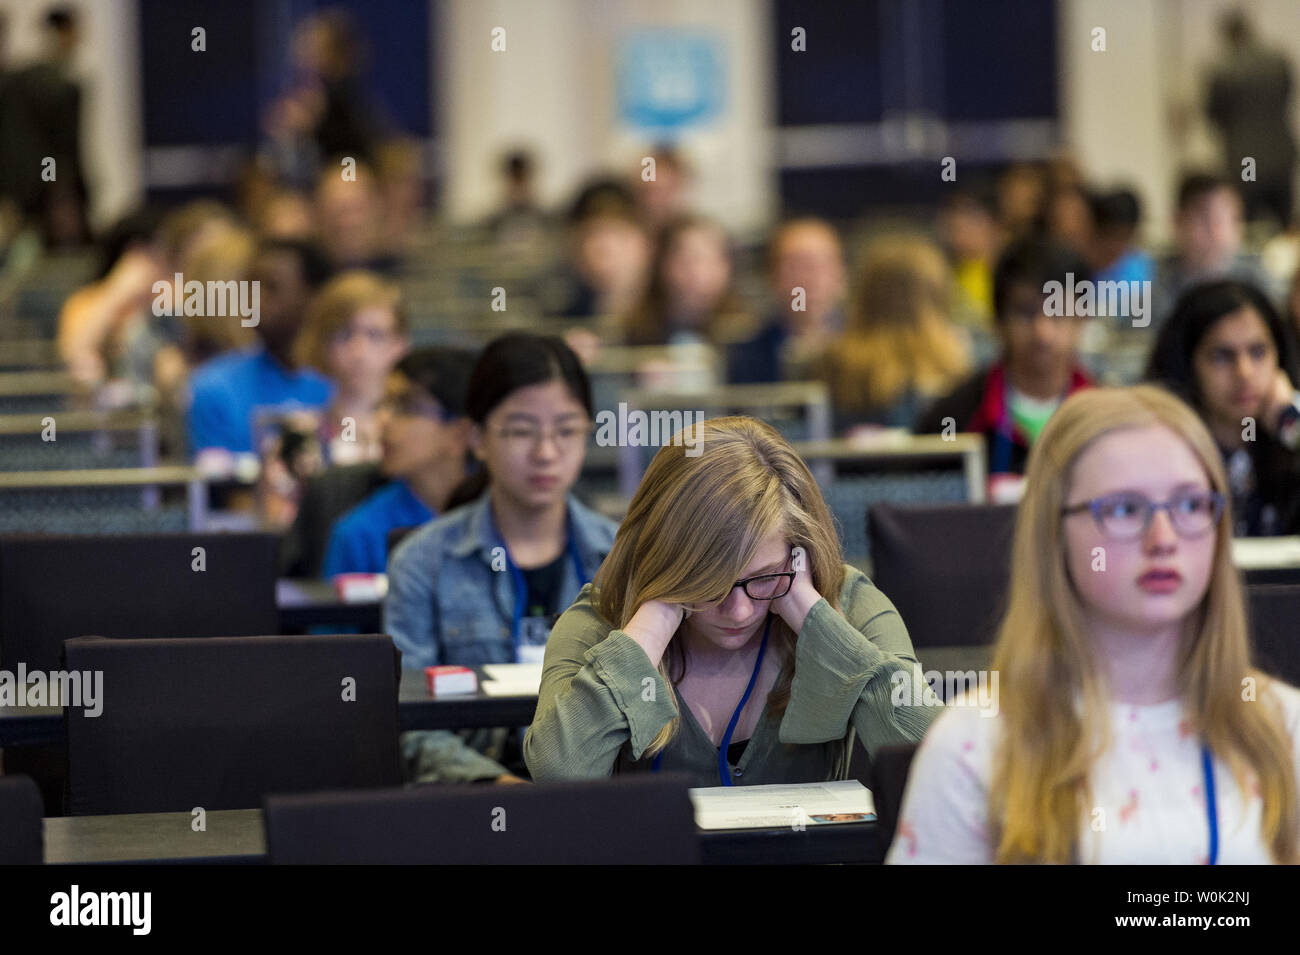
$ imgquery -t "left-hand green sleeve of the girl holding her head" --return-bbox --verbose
[524,589,677,780]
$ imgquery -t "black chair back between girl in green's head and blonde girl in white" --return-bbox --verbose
[867,504,1015,648]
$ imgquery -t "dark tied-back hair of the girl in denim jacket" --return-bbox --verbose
[443,331,595,513]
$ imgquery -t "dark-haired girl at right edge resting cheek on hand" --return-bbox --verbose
[1145,279,1300,537]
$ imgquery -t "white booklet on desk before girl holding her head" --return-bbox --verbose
[690,780,876,829]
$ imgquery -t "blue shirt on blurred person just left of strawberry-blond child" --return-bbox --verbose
[186,347,334,453]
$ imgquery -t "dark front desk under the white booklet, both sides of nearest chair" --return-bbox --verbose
[46,809,884,865]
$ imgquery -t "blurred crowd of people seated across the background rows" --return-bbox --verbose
[5,5,1300,561]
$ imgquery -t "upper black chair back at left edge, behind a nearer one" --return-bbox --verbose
[0,534,280,672]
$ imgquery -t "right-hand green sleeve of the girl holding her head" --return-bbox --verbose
[781,570,943,755]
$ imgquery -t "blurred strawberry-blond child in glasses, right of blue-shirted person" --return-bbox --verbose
[295,272,411,464]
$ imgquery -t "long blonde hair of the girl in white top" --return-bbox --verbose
[989,385,1297,863]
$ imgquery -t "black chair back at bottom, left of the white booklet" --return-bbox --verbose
[265,773,699,865]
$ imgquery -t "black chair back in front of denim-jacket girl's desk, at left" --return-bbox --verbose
[64,634,400,816]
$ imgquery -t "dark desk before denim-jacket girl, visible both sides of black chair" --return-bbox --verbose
[0,670,537,748]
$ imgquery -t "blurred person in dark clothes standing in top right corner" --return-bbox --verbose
[1205,10,1296,230]
